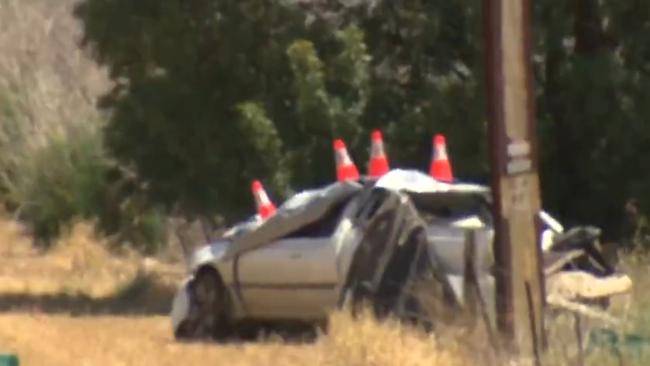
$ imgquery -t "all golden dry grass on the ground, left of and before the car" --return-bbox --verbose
[0,213,467,366]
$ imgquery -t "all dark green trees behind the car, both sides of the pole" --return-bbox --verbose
[0,0,650,250]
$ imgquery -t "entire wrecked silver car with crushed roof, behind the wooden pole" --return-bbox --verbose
[171,169,615,339]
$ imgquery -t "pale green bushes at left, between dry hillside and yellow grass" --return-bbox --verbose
[4,119,165,253]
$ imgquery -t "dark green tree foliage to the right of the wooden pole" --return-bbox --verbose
[535,0,650,236]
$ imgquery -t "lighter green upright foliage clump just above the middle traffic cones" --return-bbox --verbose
[287,27,370,186]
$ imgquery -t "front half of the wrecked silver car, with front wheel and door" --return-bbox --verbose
[171,182,363,338]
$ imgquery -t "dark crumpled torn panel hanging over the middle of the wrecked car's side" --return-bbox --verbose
[340,187,464,325]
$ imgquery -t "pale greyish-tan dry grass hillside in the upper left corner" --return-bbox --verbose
[0,0,110,148]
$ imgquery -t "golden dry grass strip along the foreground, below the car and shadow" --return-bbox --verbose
[0,314,476,366]
